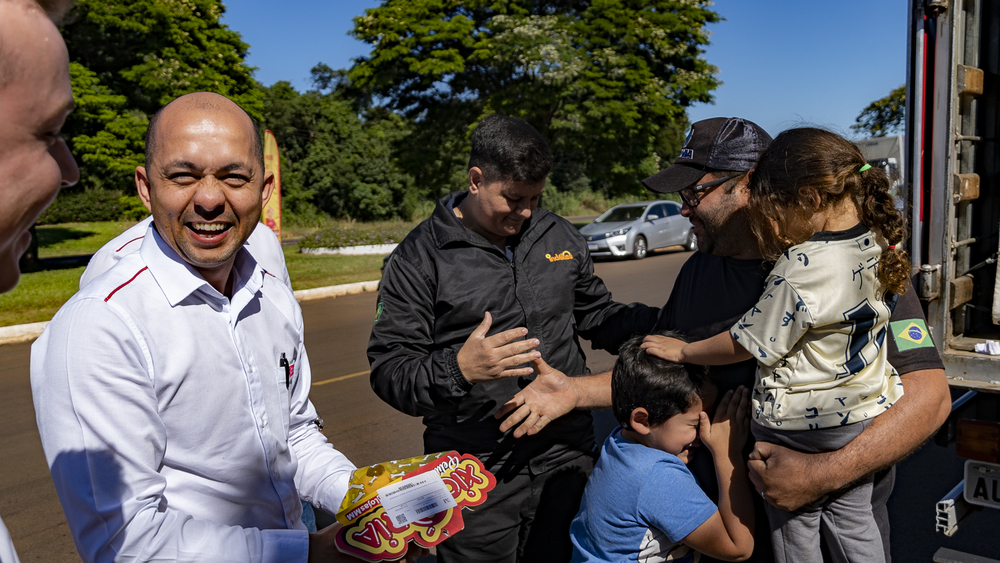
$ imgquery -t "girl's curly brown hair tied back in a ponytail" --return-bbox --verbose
[749,127,910,295]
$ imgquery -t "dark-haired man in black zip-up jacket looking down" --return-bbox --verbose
[368,115,656,563]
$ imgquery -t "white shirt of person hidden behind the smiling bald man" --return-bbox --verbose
[80,217,292,289]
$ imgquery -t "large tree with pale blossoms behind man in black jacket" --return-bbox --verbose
[349,0,719,196]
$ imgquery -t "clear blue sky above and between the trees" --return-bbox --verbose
[224,0,907,139]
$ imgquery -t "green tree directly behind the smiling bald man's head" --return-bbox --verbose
[62,0,263,192]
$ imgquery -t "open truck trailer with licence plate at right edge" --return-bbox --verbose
[900,0,1000,561]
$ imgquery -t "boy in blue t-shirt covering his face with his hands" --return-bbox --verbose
[570,334,754,563]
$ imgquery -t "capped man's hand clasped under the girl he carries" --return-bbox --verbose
[747,442,832,512]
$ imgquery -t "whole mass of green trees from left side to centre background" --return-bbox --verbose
[45,0,719,222]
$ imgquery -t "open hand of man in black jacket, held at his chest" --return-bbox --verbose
[456,311,542,383]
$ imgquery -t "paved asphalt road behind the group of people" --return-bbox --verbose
[0,248,1000,562]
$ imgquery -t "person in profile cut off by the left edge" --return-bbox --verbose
[0,0,80,563]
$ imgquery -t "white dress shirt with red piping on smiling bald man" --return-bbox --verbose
[31,227,355,562]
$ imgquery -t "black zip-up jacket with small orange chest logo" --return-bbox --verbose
[368,192,658,474]
